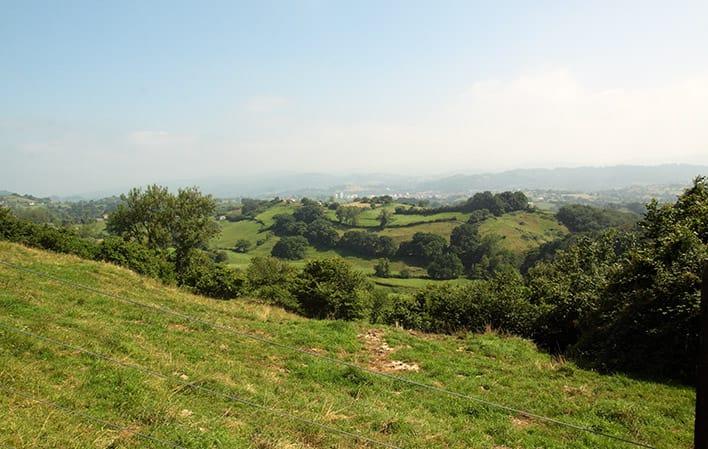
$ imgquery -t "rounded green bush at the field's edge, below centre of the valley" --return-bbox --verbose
[294,258,371,320]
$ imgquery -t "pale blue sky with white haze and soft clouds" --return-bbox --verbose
[0,0,708,195]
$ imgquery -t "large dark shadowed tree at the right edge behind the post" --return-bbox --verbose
[574,178,708,381]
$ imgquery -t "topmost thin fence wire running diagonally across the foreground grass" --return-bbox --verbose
[0,260,657,449]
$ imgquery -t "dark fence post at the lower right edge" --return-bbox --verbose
[693,262,708,449]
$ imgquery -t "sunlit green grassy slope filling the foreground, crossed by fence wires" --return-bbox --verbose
[0,242,694,449]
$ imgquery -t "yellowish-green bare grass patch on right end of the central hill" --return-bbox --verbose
[480,212,568,252]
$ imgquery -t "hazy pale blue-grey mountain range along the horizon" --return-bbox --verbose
[8,164,708,200]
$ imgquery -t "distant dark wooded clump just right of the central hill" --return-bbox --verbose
[556,204,639,232]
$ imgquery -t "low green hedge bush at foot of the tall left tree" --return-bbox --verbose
[95,237,175,283]
